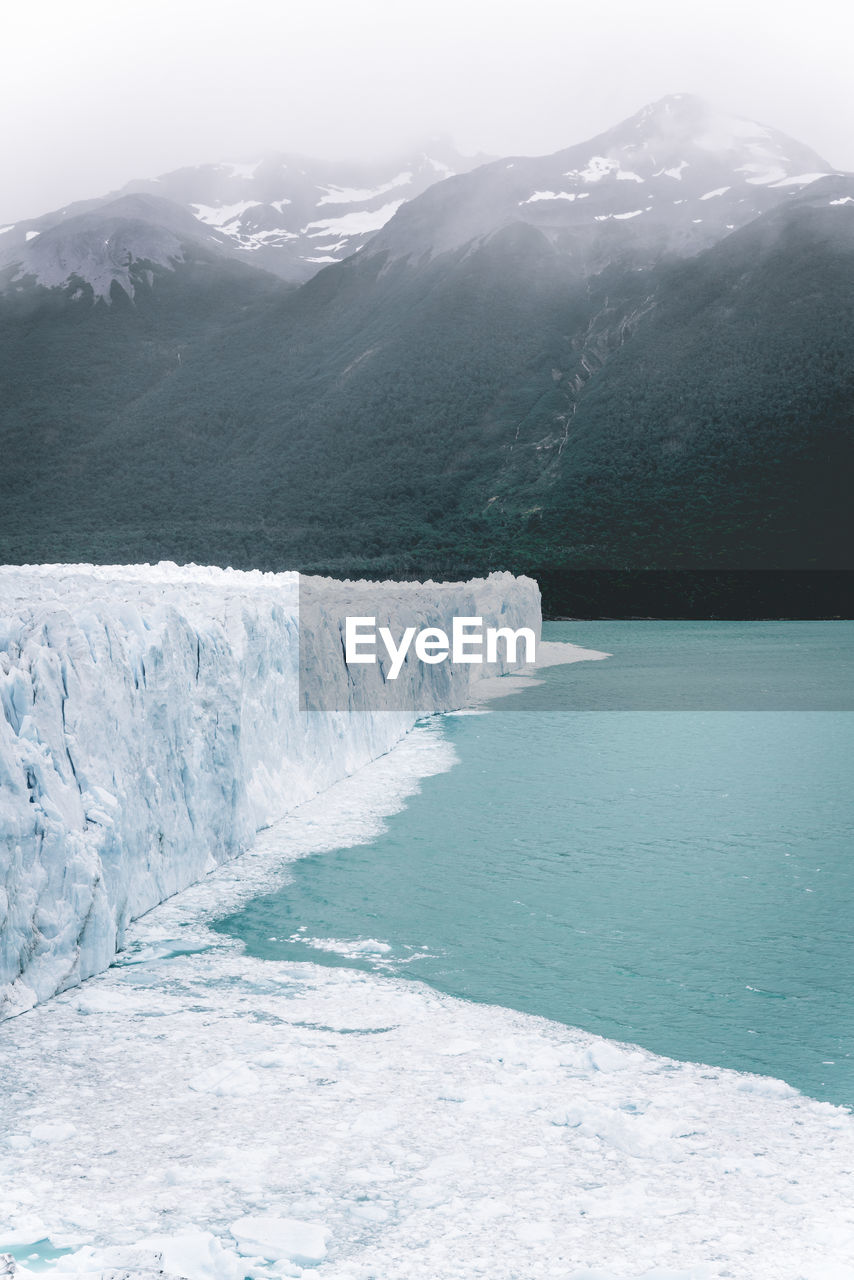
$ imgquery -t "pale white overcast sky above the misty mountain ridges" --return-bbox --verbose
[0,0,854,221]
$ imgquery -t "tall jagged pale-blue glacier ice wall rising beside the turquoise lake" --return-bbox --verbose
[0,564,540,1018]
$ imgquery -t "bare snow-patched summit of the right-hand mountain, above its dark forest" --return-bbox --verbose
[371,93,834,271]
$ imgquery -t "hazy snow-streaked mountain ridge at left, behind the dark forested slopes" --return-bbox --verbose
[0,140,485,297]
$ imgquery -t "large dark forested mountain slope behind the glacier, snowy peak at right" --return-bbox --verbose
[0,95,854,616]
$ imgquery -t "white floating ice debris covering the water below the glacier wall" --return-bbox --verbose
[0,570,854,1280]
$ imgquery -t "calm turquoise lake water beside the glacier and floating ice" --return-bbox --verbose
[218,622,854,1105]
